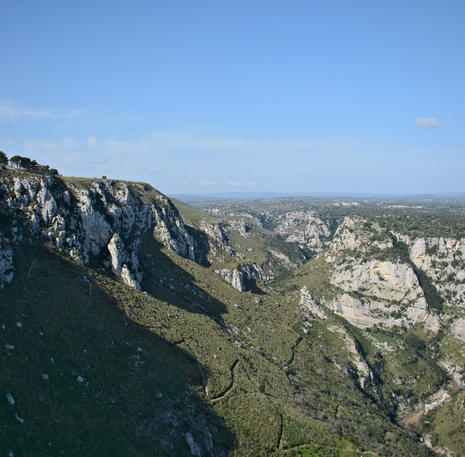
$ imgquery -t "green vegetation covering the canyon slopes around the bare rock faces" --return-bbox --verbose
[0,169,465,457]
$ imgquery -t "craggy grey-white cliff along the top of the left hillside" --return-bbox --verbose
[0,173,195,288]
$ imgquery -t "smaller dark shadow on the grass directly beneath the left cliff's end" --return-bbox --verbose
[139,233,227,325]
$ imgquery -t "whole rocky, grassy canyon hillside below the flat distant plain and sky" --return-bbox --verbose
[0,170,463,457]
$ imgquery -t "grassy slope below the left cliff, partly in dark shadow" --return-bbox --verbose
[0,178,438,457]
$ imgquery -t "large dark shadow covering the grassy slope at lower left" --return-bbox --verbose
[0,244,235,457]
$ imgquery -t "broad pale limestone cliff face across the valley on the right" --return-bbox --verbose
[300,216,440,332]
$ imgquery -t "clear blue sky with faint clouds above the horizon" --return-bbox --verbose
[0,0,465,194]
